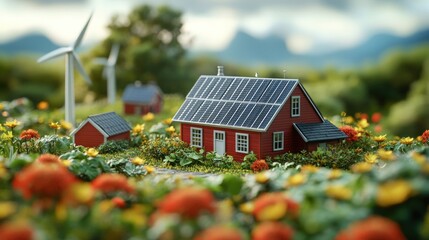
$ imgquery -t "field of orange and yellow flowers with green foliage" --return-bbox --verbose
[0,97,429,240]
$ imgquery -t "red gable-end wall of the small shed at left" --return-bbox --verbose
[74,122,104,147]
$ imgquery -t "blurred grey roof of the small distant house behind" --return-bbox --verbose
[122,83,161,103]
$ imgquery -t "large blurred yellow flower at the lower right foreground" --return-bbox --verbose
[376,180,412,207]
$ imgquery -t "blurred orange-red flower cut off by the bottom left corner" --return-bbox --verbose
[0,223,34,240]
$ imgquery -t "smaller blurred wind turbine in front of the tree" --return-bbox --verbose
[95,44,119,104]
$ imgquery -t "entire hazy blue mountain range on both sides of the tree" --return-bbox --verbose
[0,29,429,67]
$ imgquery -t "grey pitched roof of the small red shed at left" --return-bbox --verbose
[71,112,131,137]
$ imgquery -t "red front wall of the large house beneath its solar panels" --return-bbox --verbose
[180,123,261,162]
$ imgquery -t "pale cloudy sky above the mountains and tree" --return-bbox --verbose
[0,0,429,53]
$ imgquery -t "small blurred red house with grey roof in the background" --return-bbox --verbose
[122,81,163,115]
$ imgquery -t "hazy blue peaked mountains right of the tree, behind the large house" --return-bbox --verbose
[193,29,429,67]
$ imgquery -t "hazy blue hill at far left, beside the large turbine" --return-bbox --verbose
[0,33,59,55]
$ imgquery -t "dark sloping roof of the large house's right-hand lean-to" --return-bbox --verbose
[293,120,347,142]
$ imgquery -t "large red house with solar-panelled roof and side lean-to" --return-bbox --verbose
[173,66,346,161]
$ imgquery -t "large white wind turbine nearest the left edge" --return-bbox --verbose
[37,13,92,127]
